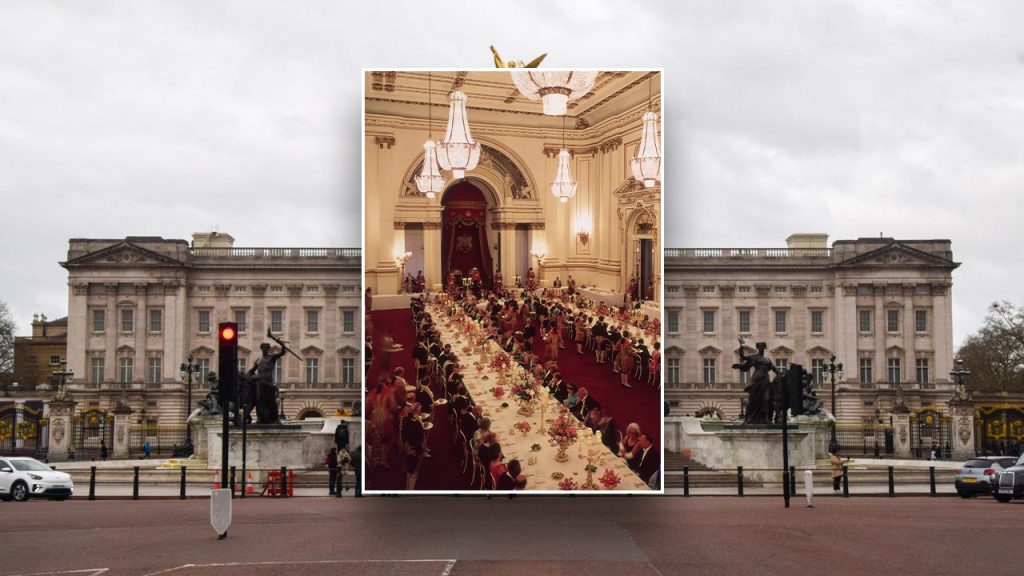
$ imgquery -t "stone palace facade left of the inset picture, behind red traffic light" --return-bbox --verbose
[60,233,362,446]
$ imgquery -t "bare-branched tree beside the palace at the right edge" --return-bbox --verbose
[957,301,1024,392]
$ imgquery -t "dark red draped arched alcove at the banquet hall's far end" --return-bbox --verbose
[441,181,494,288]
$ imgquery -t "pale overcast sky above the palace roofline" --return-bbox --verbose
[0,0,1024,342]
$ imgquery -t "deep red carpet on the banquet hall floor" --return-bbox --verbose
[367,310,662,491]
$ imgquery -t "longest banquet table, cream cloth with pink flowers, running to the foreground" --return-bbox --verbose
[431,304,650,492]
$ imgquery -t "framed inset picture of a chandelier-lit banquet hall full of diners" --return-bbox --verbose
[364,69,664,492]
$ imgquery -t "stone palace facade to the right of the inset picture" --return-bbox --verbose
[665,234,959,453]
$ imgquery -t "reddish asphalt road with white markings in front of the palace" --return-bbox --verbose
[0,496,1024,576]
